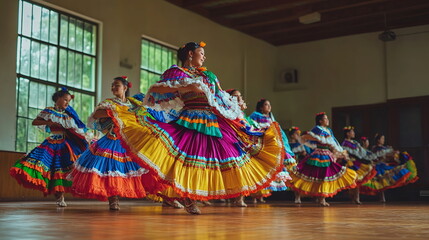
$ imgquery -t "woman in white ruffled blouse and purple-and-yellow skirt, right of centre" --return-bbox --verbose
[287,112,357,206]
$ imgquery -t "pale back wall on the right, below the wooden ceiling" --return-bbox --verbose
[271,25,429,129]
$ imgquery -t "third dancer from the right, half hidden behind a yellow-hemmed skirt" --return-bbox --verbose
[341,126,377,204]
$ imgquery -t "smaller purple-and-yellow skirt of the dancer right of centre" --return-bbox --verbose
[287,146,357,197]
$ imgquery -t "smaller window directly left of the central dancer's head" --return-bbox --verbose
[140,39,177,93]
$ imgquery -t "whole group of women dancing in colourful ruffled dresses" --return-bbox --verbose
[10,42,417,214]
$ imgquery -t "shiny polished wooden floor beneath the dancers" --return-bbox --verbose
[0,201,429,240]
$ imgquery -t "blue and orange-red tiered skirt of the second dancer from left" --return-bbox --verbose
[69,133,160,201]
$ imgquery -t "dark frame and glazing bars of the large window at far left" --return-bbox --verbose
[15,0,102,152]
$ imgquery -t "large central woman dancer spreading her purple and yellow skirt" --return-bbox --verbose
[114,42,283,214]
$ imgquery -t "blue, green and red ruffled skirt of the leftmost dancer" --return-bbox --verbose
[9,133,87,196]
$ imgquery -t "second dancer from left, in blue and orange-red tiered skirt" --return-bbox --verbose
[70,76,162,210]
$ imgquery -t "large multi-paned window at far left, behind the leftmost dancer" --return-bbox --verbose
[15,0,98,152]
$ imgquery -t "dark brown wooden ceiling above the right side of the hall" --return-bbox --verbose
[167,0,429,46]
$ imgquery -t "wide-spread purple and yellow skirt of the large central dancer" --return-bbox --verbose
[113,103,284,200]
